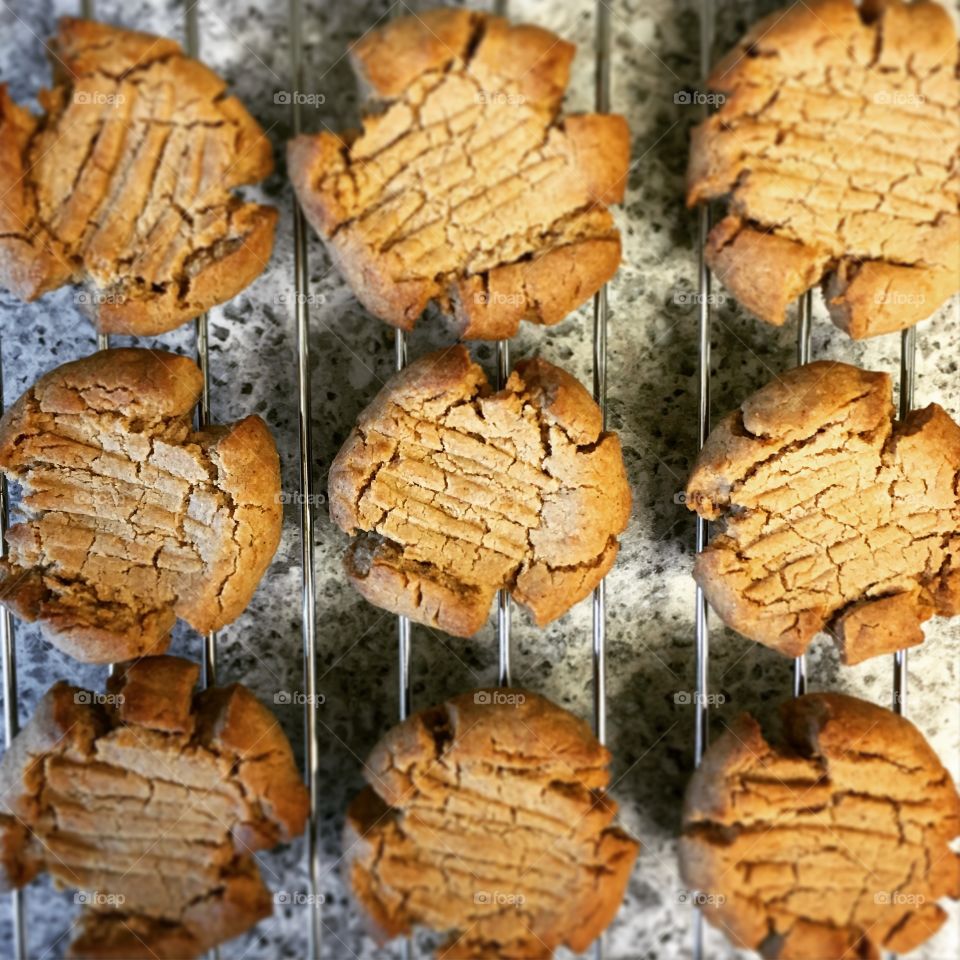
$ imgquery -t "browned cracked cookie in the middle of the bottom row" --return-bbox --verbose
[344,689,639,960]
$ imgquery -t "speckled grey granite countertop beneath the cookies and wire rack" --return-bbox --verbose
[0,0,960,960]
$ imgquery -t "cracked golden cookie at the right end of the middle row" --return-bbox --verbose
[686,360,960,663]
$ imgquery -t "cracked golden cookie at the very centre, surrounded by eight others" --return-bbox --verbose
[329,346,630,637]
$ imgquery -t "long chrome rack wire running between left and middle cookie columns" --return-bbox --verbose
[290,0,322,960]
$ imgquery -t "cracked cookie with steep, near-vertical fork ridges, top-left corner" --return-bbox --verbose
[0,17,277,335]
